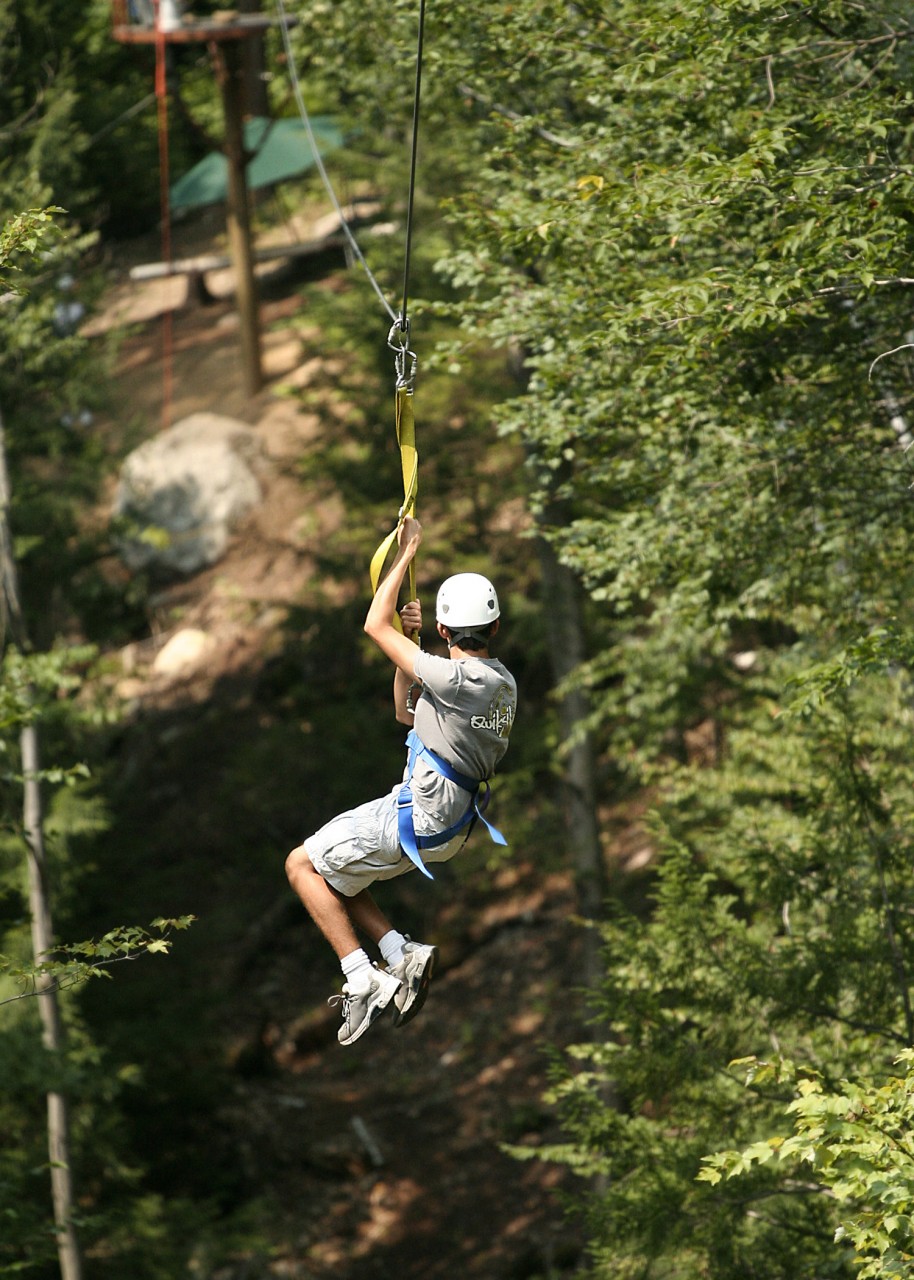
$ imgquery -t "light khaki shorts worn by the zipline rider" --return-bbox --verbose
[305,783,467,897]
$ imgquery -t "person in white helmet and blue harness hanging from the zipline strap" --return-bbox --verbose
[285,517,517,1044]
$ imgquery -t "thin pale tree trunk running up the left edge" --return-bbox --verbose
[0,412,82,1280]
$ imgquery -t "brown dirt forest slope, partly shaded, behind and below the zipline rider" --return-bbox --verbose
[74,215,643,1280]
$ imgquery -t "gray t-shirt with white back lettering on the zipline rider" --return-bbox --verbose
[412,650,517,836]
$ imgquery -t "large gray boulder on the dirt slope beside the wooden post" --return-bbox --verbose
[114,413,261,575]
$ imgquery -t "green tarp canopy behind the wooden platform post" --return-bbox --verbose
[169,115,343,212]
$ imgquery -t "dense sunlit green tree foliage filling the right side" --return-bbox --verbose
[417,0,914,1276]
